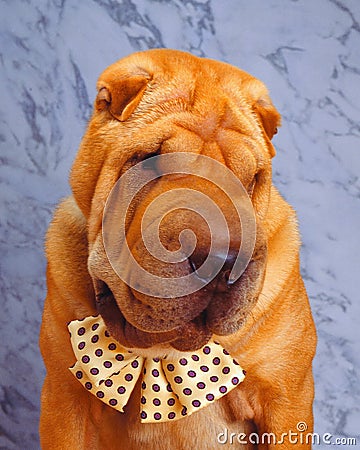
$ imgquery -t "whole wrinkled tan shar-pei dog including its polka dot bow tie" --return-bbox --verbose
[40,49,316,450]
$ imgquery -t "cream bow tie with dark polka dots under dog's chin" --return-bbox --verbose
[68,316,245,422]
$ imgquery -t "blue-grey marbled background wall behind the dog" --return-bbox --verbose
[0,0,360,449]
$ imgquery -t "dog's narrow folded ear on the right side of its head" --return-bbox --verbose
[243,77,281,157]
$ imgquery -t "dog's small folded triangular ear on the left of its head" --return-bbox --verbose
[95,74,149,122]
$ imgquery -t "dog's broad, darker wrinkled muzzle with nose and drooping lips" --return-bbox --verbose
[89,158,266,350]
